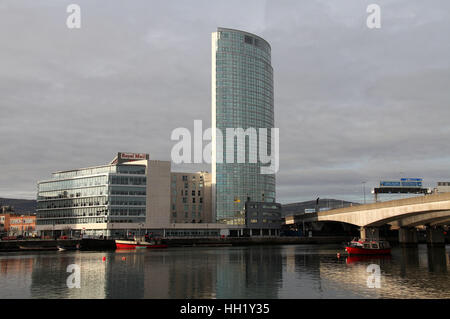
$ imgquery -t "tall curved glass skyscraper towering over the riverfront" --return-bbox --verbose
[211,28,275,225]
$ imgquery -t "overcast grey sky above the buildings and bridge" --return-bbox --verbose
[0,0,450,203]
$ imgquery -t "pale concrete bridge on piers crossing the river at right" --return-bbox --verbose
[286,193,450,245]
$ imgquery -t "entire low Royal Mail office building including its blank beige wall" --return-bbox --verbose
[36,153,170,236]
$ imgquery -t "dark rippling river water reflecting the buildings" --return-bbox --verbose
[0,245,450,299]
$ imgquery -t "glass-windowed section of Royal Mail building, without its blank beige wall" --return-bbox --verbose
[36,153,148,236]
